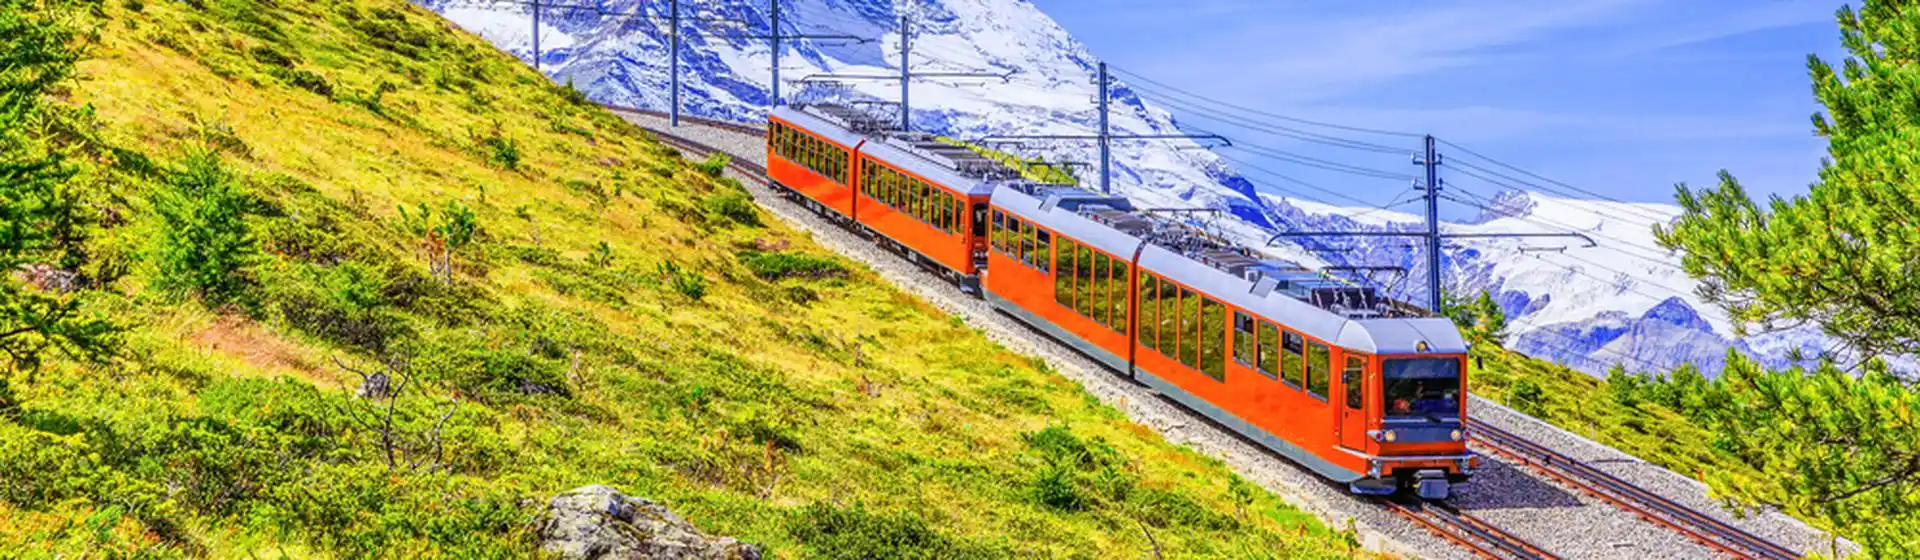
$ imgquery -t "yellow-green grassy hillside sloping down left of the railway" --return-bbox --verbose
[0,0,1350,558]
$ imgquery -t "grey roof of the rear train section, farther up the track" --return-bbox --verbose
[772,104,1059,196]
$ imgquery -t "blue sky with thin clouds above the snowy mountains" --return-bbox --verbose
[1031,0,1841,217]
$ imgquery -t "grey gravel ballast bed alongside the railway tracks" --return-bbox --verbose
[618,111,1850,560]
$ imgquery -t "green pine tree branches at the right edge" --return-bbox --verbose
[1655,0,1920,558]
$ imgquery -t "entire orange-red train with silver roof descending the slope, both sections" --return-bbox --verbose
[766,105,1476,499]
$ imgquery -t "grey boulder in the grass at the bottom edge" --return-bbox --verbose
[540,485,760,560]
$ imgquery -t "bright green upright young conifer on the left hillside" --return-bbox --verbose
[154,152,257,303]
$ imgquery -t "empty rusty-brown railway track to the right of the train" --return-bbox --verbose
[1473,422,1801,560]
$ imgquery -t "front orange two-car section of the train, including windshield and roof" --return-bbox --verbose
[983,186,1476,499]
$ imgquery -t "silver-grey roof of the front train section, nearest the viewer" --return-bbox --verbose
[993,186,1467,353]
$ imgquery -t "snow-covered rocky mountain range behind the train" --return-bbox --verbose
[415,0,1820,374]
